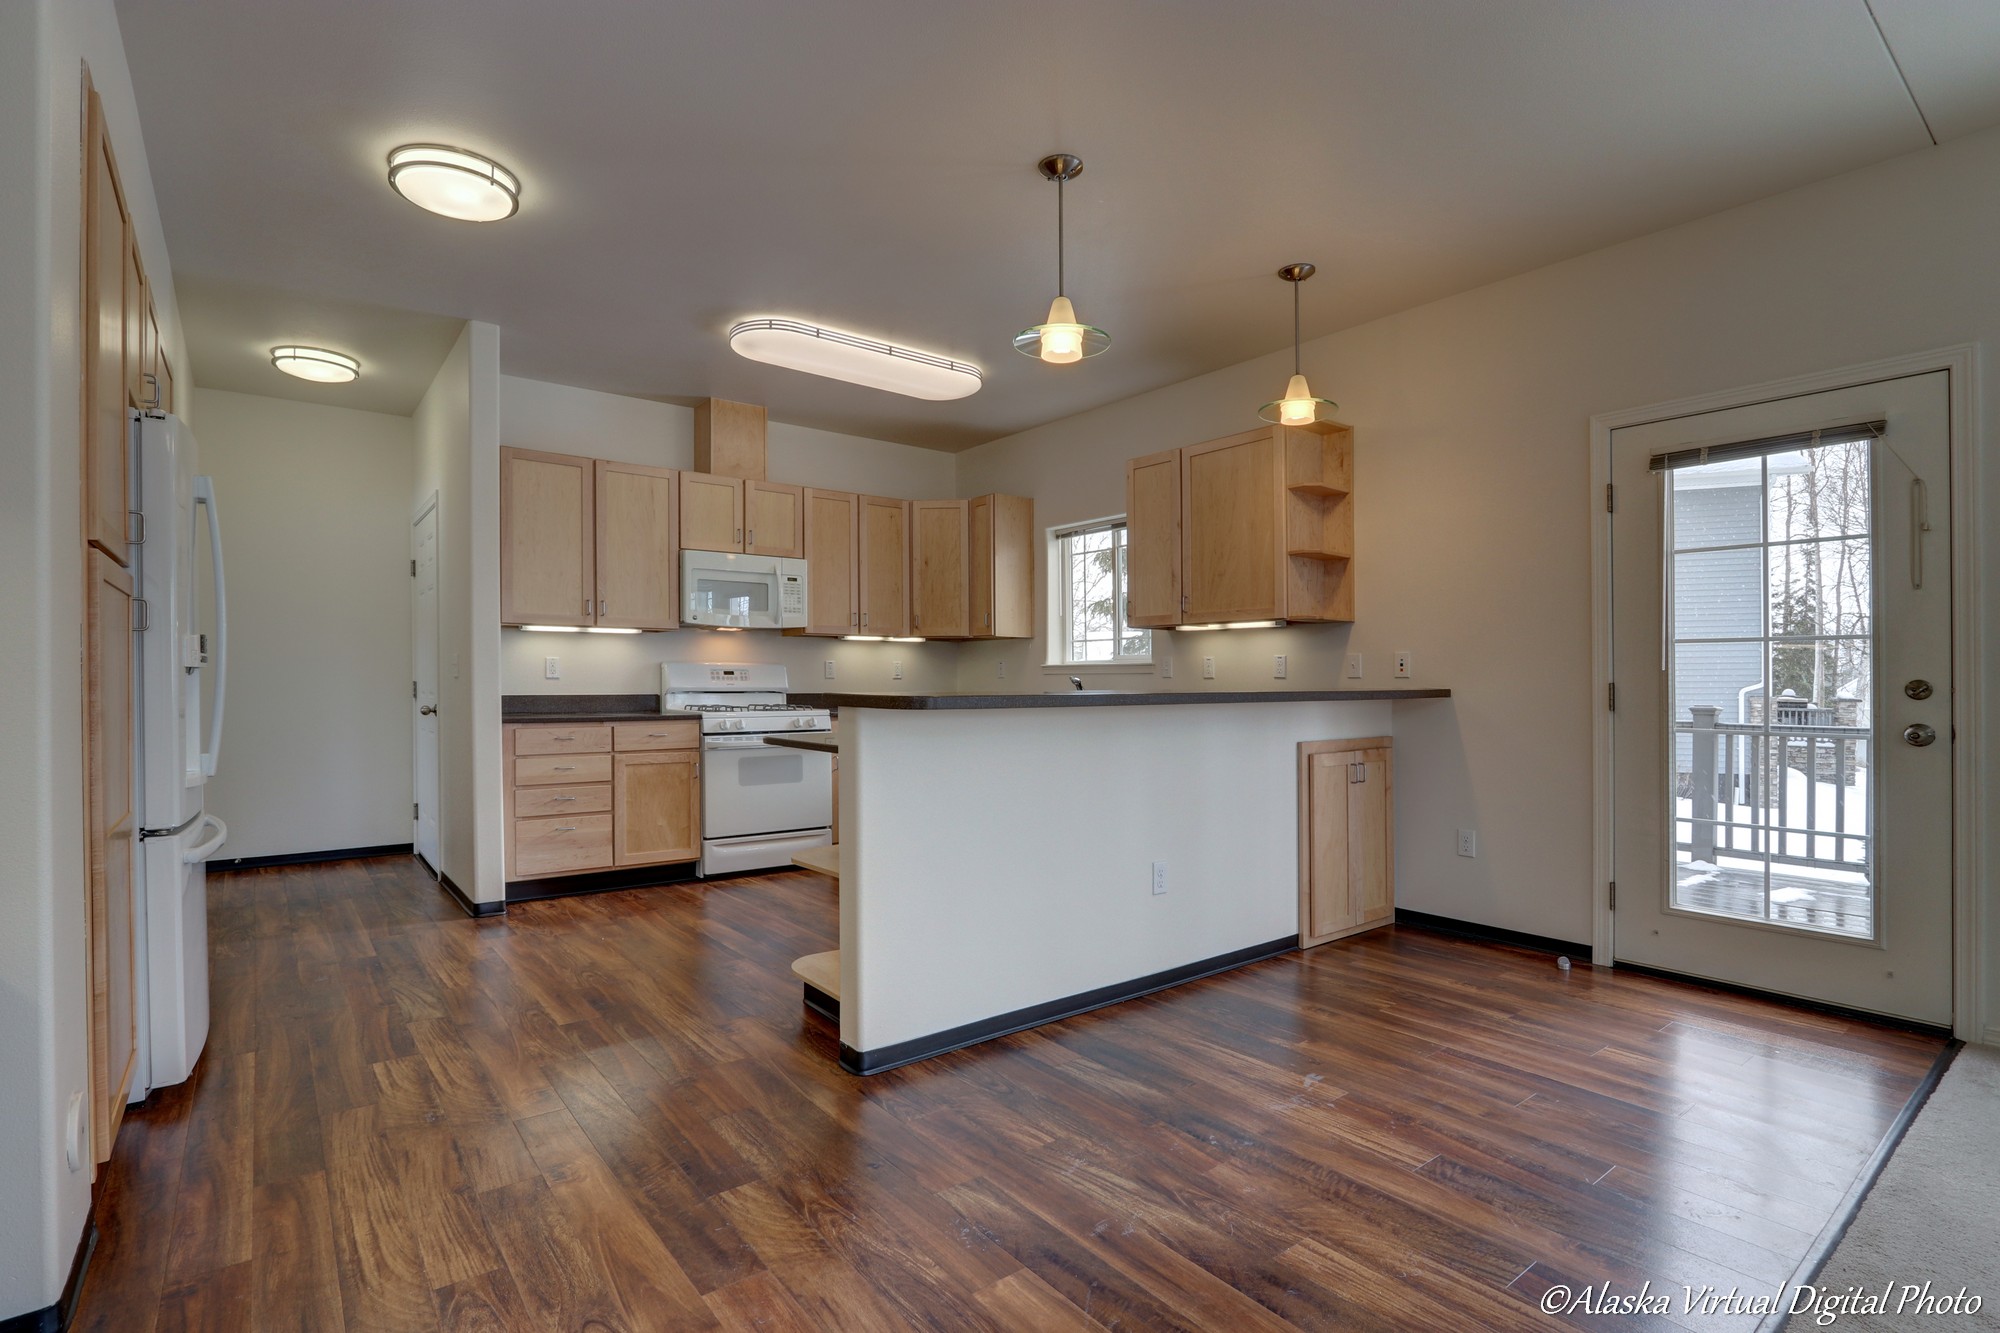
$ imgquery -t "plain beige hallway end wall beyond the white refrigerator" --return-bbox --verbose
[194,390,414,859]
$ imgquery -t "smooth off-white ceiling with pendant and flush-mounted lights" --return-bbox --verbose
[118,0,2000,448]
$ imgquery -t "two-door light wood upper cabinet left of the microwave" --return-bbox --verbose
[500,448,682,630]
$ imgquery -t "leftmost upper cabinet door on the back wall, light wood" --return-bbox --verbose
[500,448,598,624]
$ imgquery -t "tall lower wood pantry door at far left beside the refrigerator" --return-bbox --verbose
[84,550,136,1161]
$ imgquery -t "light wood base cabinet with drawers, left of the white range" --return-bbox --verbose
[506,719,702,881]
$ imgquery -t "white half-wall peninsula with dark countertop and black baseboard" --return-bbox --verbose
[794,689,1450,1073]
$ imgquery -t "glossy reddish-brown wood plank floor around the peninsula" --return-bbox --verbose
[78,859,1940,1333]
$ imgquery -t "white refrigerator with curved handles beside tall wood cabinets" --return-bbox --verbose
[132,412,228,1101]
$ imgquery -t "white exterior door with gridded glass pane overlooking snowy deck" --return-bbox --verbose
[1610,370,1952,1025]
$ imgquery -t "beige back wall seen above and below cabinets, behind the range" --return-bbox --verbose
[496,376,958,695]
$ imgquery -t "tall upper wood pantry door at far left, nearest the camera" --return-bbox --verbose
[82,92,132,564]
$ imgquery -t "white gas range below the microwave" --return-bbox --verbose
[660,662,834,875]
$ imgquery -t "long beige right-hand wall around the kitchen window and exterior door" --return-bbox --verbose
[958,132,2000,1025]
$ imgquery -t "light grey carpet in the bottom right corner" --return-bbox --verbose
[1788,1047,2000,1333]
